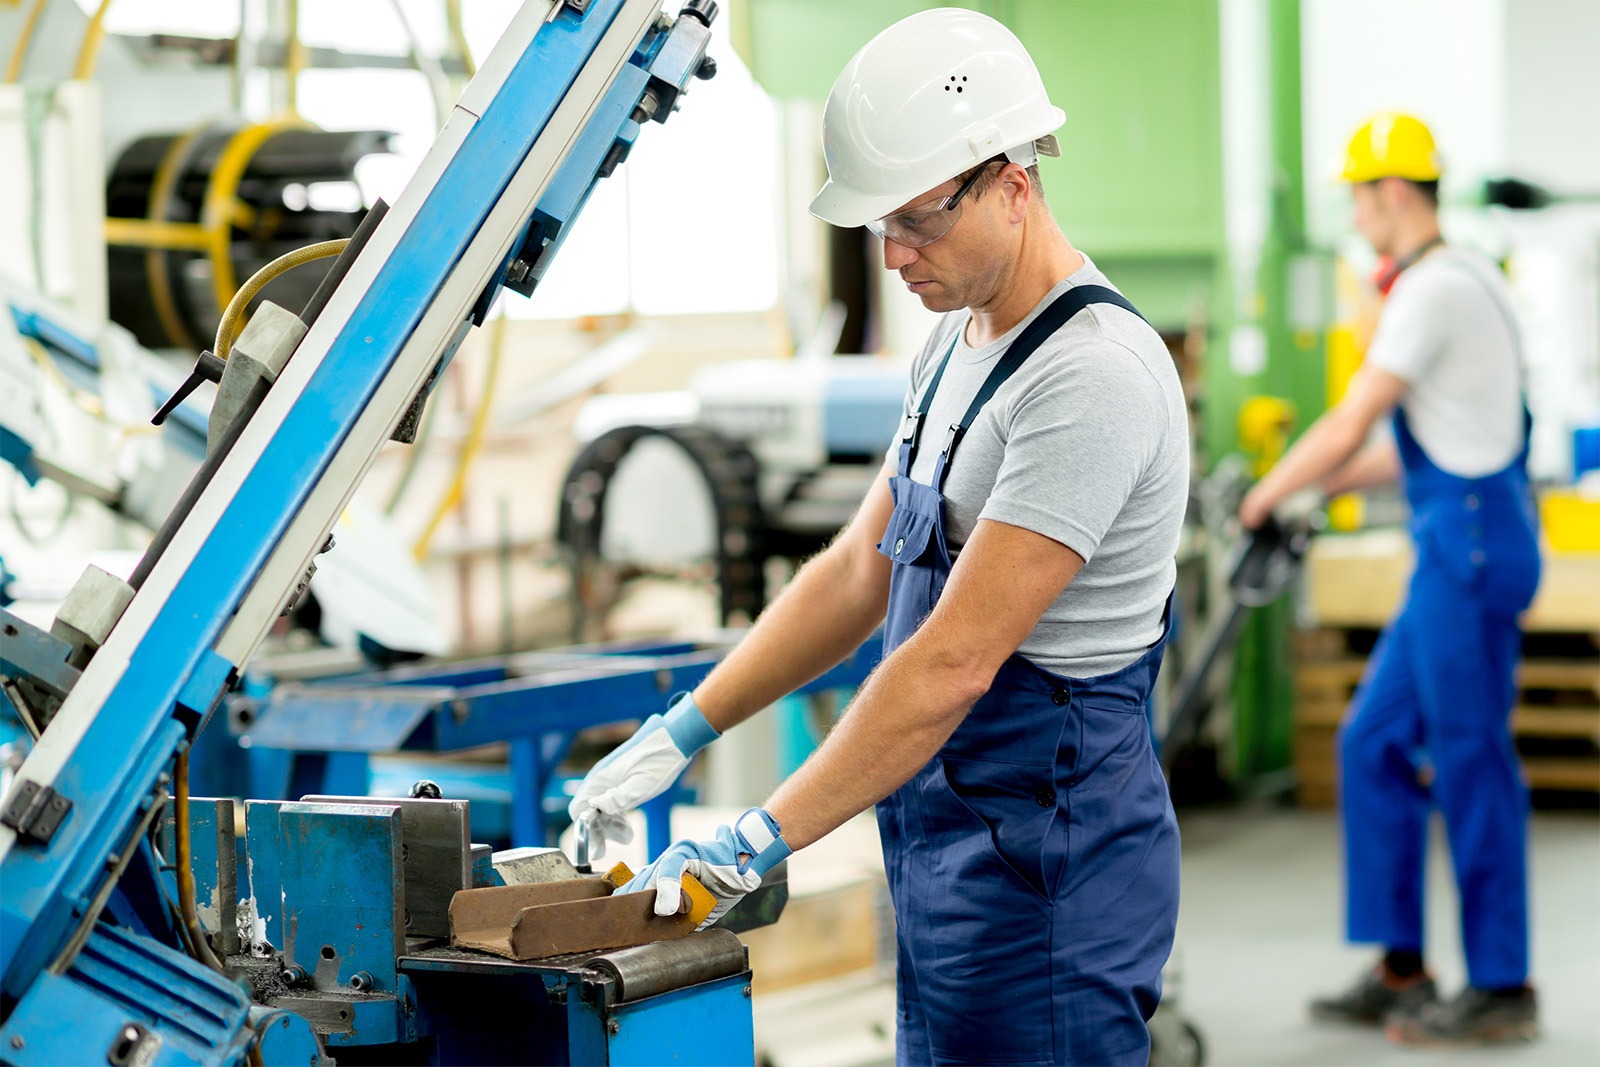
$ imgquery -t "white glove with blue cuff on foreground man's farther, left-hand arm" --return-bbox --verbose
[566,693,718,859]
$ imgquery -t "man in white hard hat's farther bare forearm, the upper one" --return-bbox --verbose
[694,544,888,733]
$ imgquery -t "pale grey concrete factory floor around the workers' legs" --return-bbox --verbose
[755,808,1600,1067]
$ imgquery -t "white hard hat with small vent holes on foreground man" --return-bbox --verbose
[811,8,1067,226]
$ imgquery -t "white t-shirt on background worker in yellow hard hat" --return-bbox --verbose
[1366,248,1523,478]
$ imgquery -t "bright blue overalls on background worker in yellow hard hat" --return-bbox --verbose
[1339,408,1539,989]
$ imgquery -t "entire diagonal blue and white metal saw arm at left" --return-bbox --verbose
[0,0,715,1022]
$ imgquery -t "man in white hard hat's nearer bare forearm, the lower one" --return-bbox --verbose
[766,638,992,849]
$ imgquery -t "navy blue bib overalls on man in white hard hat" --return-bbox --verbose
[877,286,1178,1067]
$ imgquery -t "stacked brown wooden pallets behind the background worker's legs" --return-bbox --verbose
[1294,627,1600,808]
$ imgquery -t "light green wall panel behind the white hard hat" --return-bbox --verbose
[739,0,1222,259]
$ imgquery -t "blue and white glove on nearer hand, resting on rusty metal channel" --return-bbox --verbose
[618,808,794,929]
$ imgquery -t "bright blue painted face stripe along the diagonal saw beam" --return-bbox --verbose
[0,0,636,997]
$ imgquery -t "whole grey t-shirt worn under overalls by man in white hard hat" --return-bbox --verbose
[888,258,1189,678]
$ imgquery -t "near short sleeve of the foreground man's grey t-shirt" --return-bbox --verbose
[979,341,1168,561]
